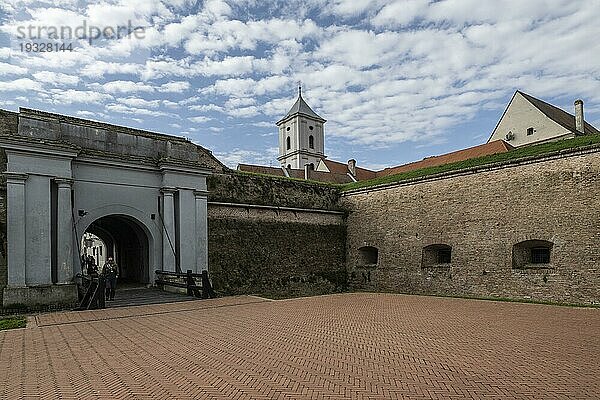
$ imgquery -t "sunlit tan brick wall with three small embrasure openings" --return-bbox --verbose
[342,148,600,304]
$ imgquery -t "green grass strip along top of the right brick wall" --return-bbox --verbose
[342,135,600,191]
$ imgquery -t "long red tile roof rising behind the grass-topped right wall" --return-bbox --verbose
[377,140,514,176]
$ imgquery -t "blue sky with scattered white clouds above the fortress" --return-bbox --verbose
[0,0,600,168]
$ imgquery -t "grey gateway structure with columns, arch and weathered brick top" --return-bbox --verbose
[0,109,222,307]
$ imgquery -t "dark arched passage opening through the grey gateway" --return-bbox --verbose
[81,214,150,284]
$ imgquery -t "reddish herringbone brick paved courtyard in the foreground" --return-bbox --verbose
[0,294,600,399]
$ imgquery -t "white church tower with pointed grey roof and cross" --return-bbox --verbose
[277,87,326,169]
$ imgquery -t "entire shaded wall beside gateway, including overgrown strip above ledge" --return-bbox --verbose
[208,174,346,297]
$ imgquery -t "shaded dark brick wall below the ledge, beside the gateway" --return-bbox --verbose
[208,204,346,296]
